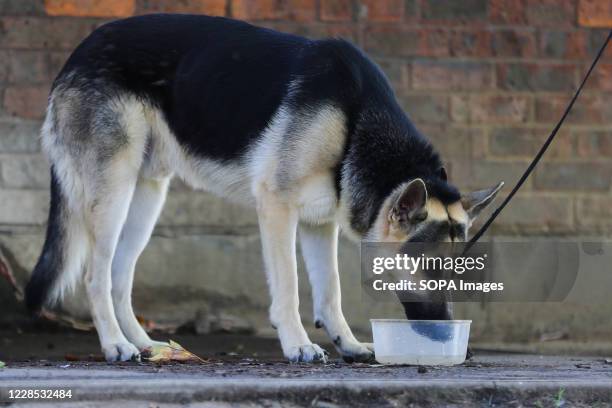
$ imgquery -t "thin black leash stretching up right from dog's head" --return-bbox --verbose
[464,30,612,249]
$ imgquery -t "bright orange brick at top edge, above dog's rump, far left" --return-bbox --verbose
[45,0,135,17]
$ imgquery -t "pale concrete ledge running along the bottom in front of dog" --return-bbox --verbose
[0,355,612,406]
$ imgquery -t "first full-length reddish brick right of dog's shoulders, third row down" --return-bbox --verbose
[412,61,493,90]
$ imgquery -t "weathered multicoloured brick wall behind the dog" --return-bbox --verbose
[0,0,612,338]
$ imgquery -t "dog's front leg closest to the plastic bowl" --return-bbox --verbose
[300,223,374,362]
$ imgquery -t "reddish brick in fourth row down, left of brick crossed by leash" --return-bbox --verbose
[451,94,530,124]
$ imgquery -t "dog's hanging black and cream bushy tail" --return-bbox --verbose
[26,166,88,313]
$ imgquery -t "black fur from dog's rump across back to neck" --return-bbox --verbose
[54,14,459,233]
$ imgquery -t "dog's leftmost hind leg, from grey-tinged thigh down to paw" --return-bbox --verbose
[78,99,150,361]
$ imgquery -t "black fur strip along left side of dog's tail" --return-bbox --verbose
[25,167,66,313]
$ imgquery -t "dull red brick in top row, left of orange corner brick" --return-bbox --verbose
[527,0,576,27]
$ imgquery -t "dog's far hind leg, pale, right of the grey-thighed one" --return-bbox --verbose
[112,177,170,351]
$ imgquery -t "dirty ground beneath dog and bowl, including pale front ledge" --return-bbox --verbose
[0,333,612,407]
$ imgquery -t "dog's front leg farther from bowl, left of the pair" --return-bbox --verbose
[257,191,326,362]
